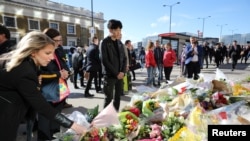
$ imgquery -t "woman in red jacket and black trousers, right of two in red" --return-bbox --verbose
[163,43,176,82]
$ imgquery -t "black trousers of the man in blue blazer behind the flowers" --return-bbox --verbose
[186,61,200,80]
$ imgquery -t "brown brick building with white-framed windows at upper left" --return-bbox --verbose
[0,0,106,46]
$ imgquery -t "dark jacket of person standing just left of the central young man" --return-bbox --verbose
[86,44,101,72]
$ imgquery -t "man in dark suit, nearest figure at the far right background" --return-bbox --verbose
[229,40,241,71]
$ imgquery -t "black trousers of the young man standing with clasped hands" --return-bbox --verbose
[103,76,123,111]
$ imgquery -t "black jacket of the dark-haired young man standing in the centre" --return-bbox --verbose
[101,37,127,78]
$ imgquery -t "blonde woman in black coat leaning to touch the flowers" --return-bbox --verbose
[0,31,87,141]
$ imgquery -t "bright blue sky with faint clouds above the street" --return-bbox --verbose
[50,0,250,42]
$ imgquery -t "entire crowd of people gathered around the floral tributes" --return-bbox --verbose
[0,19,250,141]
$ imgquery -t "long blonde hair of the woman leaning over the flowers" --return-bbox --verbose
[6,31,55,72]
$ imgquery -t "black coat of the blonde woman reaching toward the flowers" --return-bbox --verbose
[0,58,73,141]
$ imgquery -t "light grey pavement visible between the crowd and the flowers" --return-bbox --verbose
[17,63,250,141]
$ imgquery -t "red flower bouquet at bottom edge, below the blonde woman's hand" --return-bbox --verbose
[80,127,109,141]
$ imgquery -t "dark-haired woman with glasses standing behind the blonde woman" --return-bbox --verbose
[37,28,72,140]
